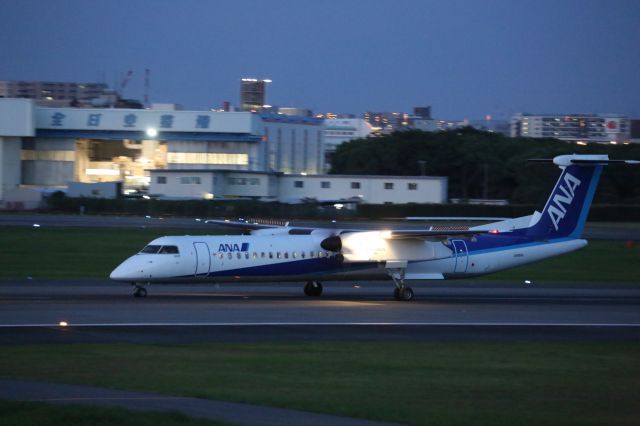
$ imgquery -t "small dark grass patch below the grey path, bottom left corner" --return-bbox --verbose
[0,401,228,426]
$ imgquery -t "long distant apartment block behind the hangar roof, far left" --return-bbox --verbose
[0,80,117,107]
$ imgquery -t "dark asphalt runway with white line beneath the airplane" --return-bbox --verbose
[0,281,640,344]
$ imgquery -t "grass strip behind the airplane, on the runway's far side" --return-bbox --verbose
[0,227,640,284]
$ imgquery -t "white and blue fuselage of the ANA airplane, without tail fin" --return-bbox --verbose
[111,235,586,283]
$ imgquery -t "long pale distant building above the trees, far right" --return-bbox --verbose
[511,113,630,143]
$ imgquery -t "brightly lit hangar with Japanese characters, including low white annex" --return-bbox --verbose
[0,98,447,208]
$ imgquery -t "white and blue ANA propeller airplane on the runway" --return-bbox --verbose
[110,154,640,301]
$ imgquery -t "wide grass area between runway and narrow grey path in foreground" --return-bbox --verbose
[0,342,640,425]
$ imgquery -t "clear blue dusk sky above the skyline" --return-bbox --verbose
[0,0,640,119]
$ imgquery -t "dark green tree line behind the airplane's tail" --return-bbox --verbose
[330,127,640,204]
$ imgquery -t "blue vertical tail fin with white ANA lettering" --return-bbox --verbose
[527,155,607,239]
